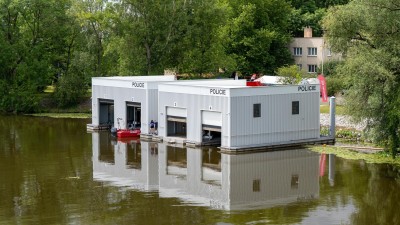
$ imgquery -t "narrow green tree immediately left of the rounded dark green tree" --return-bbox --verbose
[178,0,231,75]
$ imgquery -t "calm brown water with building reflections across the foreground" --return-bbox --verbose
[0,116,400,225]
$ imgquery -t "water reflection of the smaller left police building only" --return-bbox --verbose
[92,133,158,191]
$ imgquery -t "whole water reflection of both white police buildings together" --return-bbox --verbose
[92,133,333,210]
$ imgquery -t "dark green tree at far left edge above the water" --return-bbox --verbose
[0,0,76,112]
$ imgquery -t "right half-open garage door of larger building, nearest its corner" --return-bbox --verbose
[201,111,222,145]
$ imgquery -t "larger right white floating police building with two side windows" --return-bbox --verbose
[158,80,320,150]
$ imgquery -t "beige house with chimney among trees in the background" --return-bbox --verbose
[289,28,341,73]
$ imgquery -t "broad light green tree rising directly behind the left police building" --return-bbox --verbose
[110,0,189,74]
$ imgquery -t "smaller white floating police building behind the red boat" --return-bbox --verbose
[90,76,175,134]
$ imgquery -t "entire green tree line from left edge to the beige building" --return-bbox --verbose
[0,0,343,112]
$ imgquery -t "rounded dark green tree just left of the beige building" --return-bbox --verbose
[223,0,292,74]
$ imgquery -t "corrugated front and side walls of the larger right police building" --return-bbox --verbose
[159,89,320,148]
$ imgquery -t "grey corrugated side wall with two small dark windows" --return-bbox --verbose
[228,92,320,147]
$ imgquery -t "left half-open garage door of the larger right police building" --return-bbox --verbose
[167,107,187,138]
